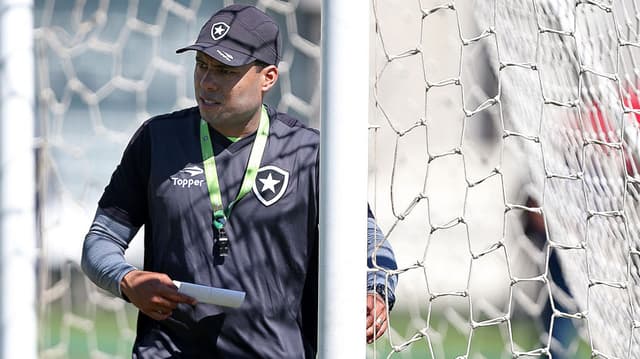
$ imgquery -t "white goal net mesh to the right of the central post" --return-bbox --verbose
[372,0,640,358]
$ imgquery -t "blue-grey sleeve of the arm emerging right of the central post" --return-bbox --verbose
[367,211,398,310]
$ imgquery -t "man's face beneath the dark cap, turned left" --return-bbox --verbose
[193,51,265,129]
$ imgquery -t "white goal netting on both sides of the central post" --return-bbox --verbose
[34,0,640,358]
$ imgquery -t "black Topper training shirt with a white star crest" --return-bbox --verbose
[99,107,319,358]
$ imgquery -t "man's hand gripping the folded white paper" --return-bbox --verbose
[120,270,196,320]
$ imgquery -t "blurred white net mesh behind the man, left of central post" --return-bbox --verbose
[34,0,320,358]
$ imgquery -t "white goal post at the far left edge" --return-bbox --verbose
[0,0,37,359]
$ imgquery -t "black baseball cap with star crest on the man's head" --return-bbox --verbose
[176,5,280,67]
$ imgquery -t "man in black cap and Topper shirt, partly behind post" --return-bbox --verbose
[82,5,396,358]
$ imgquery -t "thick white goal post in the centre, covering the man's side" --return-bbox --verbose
[318,0,370,358]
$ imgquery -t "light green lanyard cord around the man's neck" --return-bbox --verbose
[200,106,269,230]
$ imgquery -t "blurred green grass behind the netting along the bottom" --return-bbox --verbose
[39,303,591,359]
